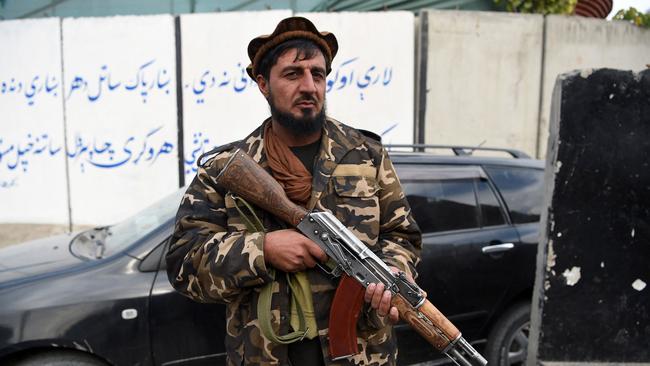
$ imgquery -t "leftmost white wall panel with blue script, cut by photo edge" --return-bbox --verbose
[0,18,68,225]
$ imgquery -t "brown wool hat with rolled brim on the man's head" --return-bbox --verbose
[246,17,339,80]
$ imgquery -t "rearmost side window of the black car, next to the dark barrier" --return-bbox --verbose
[485,166,544,224]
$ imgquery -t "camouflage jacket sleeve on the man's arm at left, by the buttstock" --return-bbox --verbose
[166,159,272,303]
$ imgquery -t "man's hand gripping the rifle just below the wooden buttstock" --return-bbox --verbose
[264,229,327,272]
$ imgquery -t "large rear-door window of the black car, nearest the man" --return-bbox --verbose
[402,179,479,233]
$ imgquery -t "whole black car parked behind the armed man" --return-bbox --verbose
[0,148,543,366]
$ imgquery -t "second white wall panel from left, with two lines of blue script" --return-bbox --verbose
[63,15,178,225]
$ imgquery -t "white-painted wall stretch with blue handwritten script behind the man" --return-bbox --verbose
[0,11,414,225]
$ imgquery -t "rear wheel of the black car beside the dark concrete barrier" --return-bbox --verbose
[485,303,530,366]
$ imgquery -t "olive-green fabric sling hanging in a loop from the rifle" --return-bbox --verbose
[230,194,318,344]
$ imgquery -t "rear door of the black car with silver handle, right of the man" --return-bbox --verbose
[390,164,519,363]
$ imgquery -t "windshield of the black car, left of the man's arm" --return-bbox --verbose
[70,188,185,259]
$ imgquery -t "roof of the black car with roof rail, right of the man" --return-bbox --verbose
[389,151,544,169]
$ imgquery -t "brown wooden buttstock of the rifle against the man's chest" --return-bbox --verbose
[217,149,308,227]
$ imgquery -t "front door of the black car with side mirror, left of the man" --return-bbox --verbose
[145,241,226,366]
